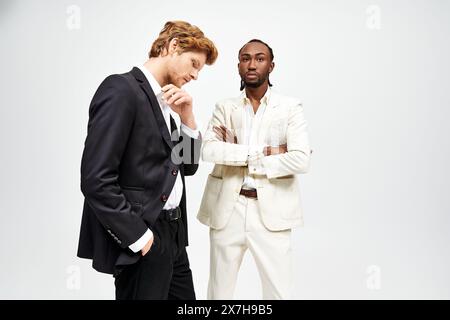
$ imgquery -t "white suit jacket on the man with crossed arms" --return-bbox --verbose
[197,90,311,231]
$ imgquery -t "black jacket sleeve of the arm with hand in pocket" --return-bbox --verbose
[81,75,148,248]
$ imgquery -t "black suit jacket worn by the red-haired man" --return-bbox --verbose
[78,68,201,274]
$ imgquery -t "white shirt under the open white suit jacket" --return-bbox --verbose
[241,88,270,189]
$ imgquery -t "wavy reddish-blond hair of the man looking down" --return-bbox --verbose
[148,21,218,65]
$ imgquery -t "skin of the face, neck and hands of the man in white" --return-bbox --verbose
[213,42,287,156]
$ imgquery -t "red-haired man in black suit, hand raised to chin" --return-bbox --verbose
[78,21,217,299]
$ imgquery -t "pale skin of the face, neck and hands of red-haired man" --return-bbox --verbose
[141,38,206,256]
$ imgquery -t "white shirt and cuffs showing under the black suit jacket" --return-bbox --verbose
[129,66,199,252]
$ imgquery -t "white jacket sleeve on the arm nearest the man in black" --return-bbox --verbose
[202,103,249,166]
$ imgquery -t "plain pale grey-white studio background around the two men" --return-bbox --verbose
[0,0,450,299]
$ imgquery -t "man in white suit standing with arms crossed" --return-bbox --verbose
[198,39,311,299]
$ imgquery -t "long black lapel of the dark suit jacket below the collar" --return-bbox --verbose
[131,67,174,149]
